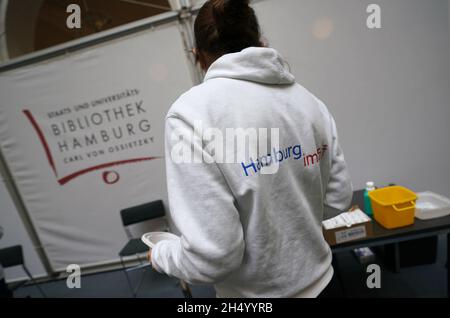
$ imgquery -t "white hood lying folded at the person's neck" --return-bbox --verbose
[204,47,295,85]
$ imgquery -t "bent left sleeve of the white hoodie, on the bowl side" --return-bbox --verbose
[152,117,245,284]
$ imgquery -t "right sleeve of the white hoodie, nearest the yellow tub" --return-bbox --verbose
[324,114,353,211]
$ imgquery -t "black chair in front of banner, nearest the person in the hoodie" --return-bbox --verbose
[119,200,191,298]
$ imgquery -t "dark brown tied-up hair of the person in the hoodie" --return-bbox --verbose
[194,0,263,55]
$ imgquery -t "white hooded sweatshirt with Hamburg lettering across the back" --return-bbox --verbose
[152,48,352,297]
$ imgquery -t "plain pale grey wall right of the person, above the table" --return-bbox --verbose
[255,0,450,196]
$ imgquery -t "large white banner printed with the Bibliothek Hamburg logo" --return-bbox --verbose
[0,24,192,271]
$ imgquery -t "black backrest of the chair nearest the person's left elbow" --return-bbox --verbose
[120,200,166,226]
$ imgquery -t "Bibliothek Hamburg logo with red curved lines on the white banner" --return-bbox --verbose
[23,89,162,186]
